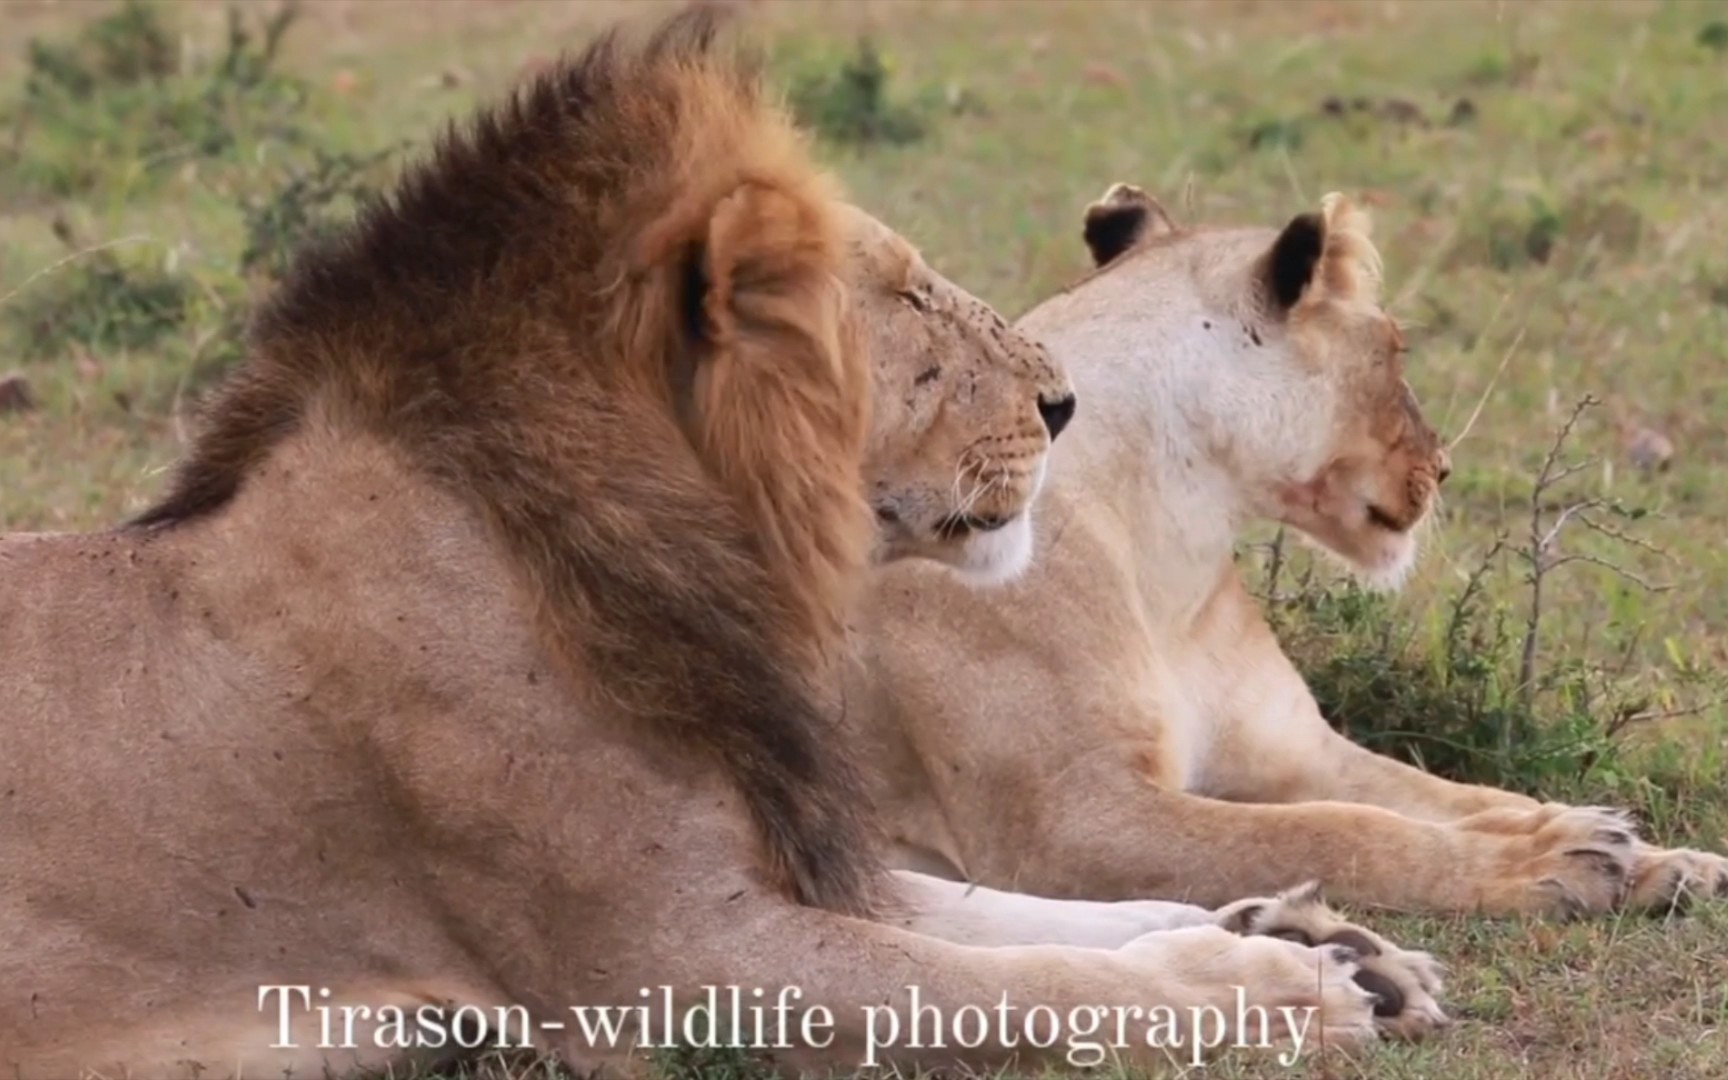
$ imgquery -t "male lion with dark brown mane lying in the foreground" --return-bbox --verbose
[0,14,1443,1080]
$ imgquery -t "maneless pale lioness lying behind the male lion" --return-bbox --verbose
[855,185,1728,912]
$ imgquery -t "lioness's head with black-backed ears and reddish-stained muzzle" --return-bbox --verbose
[1083,183,1450,586]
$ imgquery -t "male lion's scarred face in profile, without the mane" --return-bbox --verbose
[847,207,1075,581]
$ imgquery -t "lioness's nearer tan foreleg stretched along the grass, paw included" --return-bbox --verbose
[954,739,1635,914]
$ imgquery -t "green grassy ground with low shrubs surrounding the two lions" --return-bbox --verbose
[0,0,1728,1080]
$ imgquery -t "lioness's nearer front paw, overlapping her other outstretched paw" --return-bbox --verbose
[1457,804,1638,918]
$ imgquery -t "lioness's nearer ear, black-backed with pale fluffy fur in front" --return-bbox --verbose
[1260,192,1381,311]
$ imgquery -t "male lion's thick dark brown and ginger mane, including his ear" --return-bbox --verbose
[131,9,878,912]
